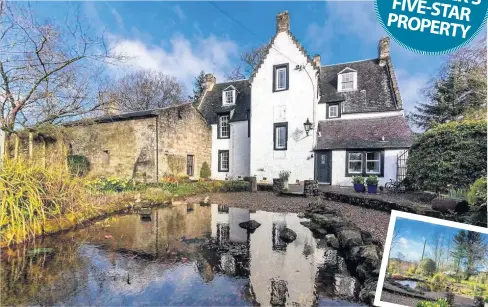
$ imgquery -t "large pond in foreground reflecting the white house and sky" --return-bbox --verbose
[0,204,366,306]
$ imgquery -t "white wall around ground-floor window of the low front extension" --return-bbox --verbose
[332,149,406,186]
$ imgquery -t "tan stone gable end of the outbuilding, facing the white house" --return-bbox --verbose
[158,104,212,179]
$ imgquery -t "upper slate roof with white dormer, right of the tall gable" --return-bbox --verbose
[319,59,402,114]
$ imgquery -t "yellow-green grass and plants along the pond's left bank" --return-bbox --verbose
[0,159,248,247]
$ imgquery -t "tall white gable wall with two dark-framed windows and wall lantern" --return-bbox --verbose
[250,32,317,182]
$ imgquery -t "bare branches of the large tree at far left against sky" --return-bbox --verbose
[0,1,123,136]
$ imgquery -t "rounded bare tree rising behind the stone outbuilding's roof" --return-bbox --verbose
[110,70,183,112]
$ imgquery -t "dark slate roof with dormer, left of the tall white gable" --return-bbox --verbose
[198,80,251,125]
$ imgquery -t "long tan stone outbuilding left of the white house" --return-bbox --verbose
[65,103,211,182]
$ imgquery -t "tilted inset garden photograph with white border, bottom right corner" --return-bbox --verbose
[375,211,488,307]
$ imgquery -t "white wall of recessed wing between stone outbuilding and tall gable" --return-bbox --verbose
[211,121,250,180]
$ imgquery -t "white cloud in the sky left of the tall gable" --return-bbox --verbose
[113,34,238,92]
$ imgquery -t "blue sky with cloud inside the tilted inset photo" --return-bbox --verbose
[390,217,488,261]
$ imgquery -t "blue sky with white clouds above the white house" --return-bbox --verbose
[28,1,486,115]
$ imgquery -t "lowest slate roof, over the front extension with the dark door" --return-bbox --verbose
[315,116,413,150]
